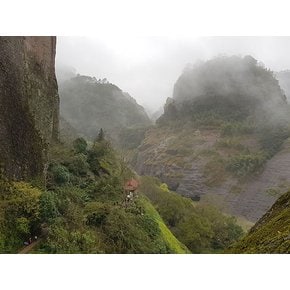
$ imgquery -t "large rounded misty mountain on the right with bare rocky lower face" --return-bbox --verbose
[135,57,290,222]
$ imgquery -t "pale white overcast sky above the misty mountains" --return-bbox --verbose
[56,34,290,112]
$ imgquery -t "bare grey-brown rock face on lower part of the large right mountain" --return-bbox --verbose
[135,127,290,222]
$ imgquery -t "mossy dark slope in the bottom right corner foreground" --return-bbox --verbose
[227,192,290,253]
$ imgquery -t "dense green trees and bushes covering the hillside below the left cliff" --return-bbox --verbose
[0,135,189,253]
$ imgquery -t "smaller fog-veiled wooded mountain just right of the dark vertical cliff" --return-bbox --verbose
[59,75,151,143]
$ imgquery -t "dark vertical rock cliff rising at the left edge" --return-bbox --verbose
[0,37,59,179]
